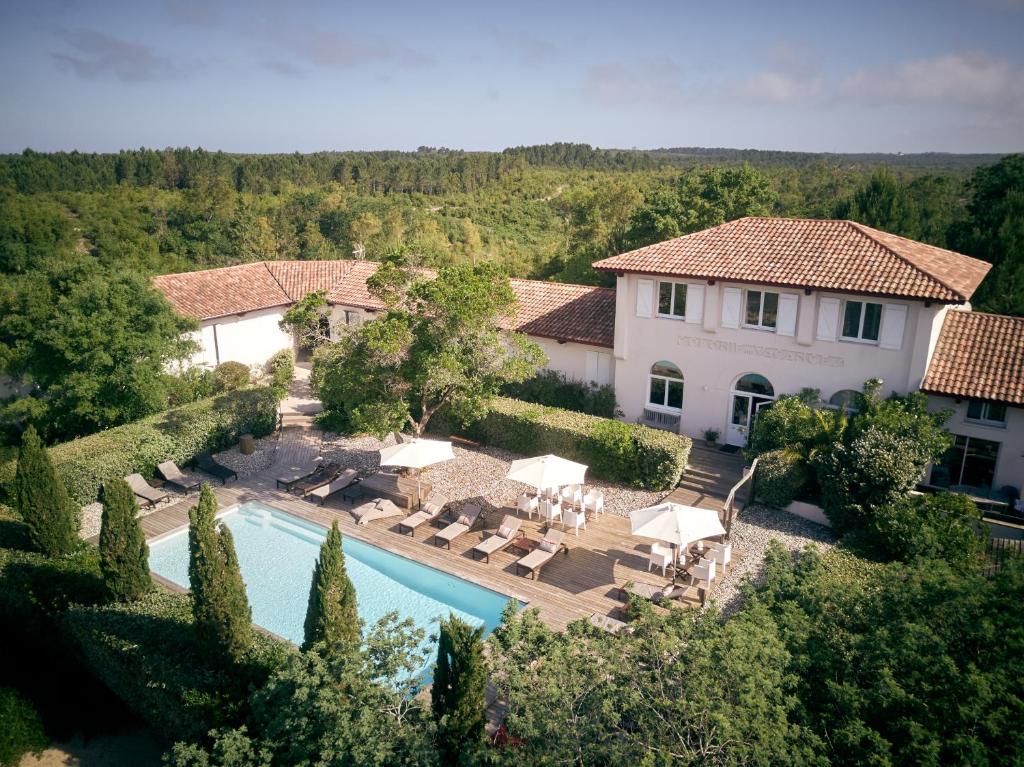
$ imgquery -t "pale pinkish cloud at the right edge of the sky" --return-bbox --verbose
[840,52,1024,112]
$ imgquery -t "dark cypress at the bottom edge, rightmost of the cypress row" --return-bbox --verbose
[430,615,487,765]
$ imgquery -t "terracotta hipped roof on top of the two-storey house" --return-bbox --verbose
[594,217,991,303]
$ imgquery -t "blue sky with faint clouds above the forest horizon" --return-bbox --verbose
[0,0,1024,153]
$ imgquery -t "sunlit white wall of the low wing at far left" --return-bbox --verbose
[191,308,294,367]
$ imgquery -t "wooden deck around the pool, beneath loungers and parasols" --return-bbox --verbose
[140,471,739,630]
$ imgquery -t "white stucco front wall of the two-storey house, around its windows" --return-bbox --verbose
[614,274,944,439]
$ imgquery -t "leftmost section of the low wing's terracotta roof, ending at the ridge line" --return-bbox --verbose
[153,261,292,319]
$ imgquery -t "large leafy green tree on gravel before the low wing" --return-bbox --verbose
[311,263,545,435]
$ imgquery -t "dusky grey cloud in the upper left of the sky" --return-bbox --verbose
[50,29,192,82]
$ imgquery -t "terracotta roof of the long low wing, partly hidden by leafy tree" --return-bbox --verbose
[154,260,615,348]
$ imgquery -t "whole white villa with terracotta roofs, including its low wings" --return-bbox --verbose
[156,218,1024,499]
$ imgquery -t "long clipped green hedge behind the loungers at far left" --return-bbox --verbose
[0,388,278,504]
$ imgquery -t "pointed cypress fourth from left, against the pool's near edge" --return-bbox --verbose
[302,519,359,650]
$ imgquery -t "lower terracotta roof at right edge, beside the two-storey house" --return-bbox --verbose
[921,311,1024,406]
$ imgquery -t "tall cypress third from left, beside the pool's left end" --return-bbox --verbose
[188,484,252,662]
